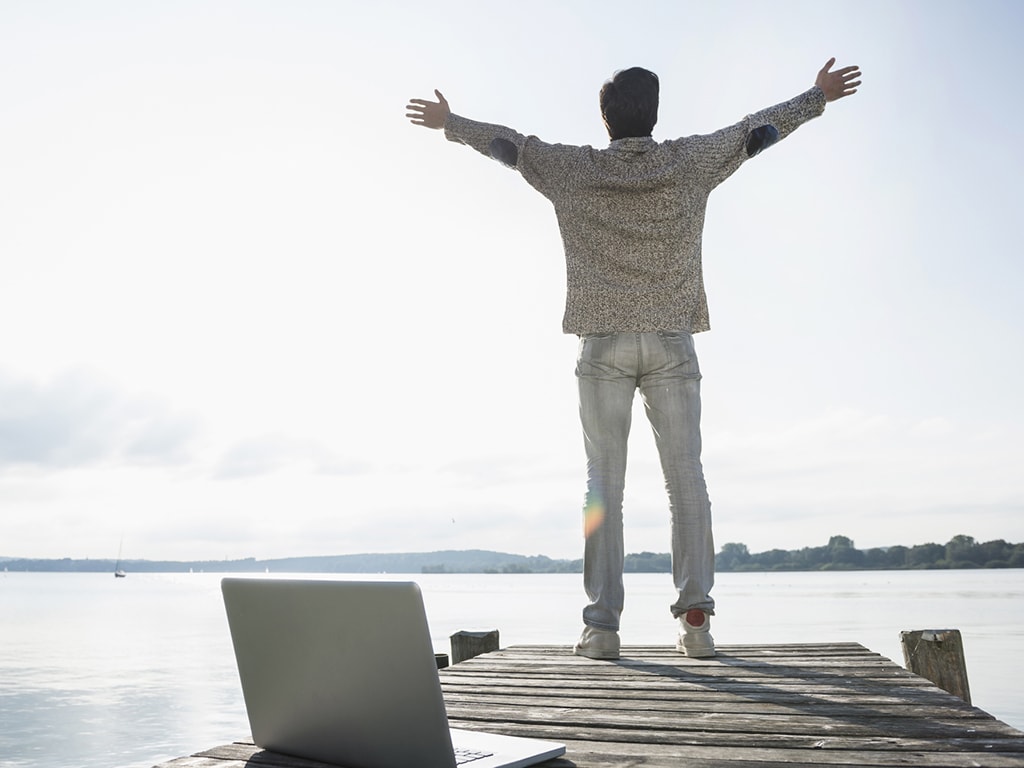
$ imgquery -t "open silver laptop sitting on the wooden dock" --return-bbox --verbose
[221,578,565,768]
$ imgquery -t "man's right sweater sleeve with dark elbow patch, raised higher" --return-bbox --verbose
[680,86,825,189]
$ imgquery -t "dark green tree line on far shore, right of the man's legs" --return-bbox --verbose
[715,535,1024,571]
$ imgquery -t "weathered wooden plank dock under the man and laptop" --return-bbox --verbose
[159,643,1024,768]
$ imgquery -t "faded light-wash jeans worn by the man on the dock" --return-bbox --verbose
[575,331,715,630]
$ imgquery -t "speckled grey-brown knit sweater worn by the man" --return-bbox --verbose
[444,86,825,336]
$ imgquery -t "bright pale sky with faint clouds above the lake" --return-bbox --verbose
[0,0,1024,560]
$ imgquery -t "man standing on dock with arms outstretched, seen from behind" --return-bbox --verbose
[407,58,860,658]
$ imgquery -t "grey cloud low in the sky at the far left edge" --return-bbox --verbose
[0,370,200,469]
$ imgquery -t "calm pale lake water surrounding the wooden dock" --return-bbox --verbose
[0,569,1024,768]
